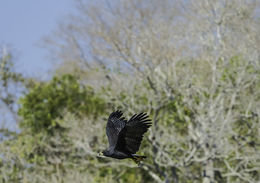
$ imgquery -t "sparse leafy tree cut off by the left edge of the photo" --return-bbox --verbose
[0,46,25,182]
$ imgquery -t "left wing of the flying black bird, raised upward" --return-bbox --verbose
[106,111,126,148]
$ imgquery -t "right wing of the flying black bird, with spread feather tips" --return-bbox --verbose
[116,113,152,154]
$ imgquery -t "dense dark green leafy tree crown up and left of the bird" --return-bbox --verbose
[18,75,105,133]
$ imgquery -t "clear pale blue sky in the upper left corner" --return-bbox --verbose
[0,0,74,79]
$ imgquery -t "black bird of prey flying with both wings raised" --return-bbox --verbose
[100,110,152,164]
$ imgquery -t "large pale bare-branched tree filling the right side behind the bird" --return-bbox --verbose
[43,0,260,183]
